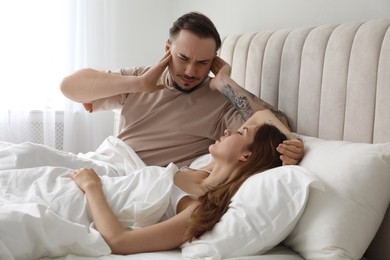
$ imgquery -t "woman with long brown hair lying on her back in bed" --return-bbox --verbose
[71,110,291,254]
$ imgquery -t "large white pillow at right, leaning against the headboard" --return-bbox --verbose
[284,136,390,260]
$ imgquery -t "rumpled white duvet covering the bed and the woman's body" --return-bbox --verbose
[0,137,177,260]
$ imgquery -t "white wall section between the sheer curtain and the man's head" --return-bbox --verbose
[105,0,175,69]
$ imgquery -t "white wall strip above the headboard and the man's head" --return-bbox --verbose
[174,0,390,35]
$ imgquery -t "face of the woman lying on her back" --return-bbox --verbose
[209,125,258,162]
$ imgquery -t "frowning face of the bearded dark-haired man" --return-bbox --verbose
[166,30,216,92]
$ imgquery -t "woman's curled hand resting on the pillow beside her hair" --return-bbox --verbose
[276,139,305,165]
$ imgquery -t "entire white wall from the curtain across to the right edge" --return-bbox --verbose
[110,0,390,69]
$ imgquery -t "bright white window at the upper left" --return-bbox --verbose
[0,0,70,110]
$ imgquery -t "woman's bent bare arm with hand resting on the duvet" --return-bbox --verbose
[72,169,195,254]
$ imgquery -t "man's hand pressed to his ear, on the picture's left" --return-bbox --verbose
[140,51,172,93]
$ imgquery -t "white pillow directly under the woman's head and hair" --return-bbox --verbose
[182,158,321,259]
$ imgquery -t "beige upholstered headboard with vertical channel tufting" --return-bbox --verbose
[220,19,390,259]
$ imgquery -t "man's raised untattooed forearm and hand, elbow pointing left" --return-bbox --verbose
[61,52,171,103]
